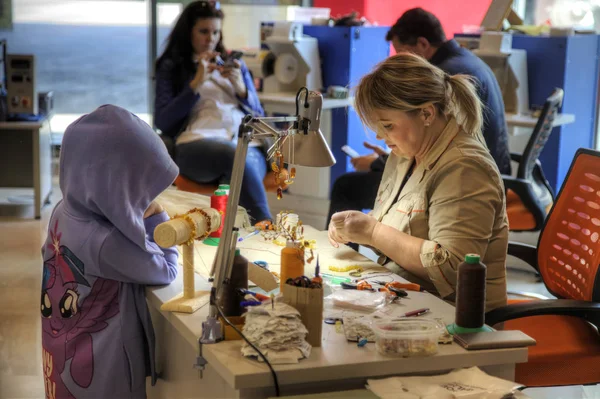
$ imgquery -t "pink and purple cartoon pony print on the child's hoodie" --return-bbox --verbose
[41,221,119,398]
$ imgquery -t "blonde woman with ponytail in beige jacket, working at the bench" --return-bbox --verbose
[329,53,508,311]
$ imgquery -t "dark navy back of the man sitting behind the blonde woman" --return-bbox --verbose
[430,40,511,174]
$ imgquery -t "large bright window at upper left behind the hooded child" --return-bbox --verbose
[2,0,181,142]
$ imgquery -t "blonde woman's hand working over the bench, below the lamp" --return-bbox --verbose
[328,211,379,248]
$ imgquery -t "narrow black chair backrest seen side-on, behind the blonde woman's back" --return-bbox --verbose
[517,89,564,180]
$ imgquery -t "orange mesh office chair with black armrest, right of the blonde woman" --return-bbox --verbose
[486,149,600,387]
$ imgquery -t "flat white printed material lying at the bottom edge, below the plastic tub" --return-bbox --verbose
[367,367,523,399]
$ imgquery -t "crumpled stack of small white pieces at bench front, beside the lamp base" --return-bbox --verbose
[242,302,311,364]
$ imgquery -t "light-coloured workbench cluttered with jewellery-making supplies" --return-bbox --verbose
[147,190,527,399]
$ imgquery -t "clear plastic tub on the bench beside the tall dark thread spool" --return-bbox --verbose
[372,318,440,357]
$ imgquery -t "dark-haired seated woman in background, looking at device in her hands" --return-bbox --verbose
[154,1,271,222]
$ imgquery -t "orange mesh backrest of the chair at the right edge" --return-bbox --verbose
[537,149,600,302]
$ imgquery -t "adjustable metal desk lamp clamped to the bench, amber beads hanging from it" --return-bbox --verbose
[200,87,335,344]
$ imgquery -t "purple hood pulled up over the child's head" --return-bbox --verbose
[60,105,179,249]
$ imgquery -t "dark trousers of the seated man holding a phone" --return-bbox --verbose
[325,171,383,250]
